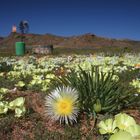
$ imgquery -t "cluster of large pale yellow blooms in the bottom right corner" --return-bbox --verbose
[98,113,140,140]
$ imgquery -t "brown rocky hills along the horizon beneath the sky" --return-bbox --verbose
[0,33,140,48]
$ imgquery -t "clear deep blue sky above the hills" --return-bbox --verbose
[0,0,140,40]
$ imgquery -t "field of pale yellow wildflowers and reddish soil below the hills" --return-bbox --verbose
[0,53,140,140]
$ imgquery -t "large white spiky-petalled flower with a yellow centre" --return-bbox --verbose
[45,87,79,124]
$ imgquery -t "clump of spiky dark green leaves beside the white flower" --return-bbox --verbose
[52,66,137,115]
